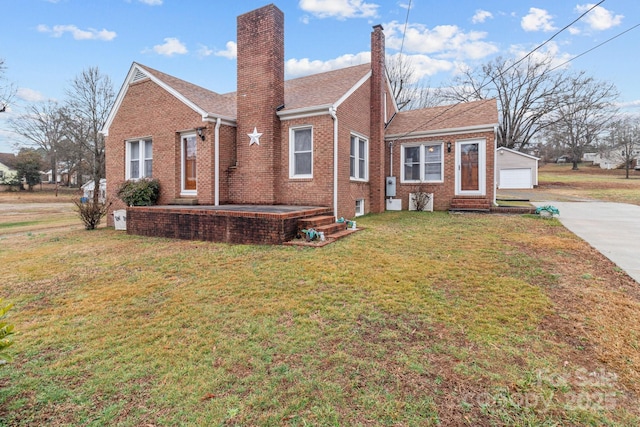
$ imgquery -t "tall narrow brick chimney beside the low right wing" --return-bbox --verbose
[369,25,387,212]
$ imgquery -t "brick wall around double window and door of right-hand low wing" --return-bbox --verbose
[387,132,495,211]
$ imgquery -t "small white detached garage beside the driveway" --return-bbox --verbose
[496,147,540,189]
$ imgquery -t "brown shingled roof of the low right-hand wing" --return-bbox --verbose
[385,99,498,139]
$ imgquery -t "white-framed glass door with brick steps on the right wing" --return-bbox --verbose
[456,140,486,195]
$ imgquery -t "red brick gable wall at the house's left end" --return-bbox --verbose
[105,80,213,225]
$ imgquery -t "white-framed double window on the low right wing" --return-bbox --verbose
[402,142,444,182]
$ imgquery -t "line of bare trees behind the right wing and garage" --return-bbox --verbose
[387,54,640,174]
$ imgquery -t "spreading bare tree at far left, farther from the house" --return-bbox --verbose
[9,101,65,182]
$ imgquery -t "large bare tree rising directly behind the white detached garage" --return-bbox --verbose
[443,56,567,150]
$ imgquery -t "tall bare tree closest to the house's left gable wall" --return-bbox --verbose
[65,67,115,205]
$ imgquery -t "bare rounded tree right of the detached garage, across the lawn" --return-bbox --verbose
[546,72,618,170]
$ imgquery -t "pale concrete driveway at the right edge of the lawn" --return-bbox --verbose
[532,201,640,283]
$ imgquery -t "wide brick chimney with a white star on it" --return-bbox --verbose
[230,4,284,204]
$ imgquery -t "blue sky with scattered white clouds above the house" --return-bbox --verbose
[0,0,640,152]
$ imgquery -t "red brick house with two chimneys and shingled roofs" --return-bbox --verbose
[103,5,497,244]
